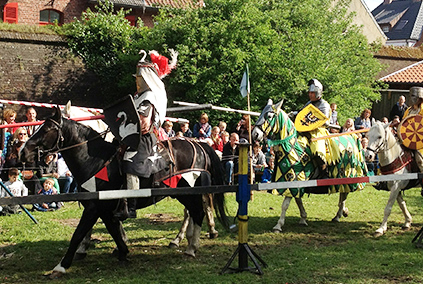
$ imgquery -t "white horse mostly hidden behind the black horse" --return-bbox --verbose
[63,101,219,253]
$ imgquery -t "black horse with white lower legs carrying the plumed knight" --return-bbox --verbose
[20,108,228,277]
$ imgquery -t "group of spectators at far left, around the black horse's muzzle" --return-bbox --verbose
[0,107,77,215]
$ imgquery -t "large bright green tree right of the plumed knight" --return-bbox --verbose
[144,0,381,123]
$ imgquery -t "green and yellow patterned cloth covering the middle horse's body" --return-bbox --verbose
[268,117,367,197]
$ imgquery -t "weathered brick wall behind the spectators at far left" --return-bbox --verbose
[0,32,104,121]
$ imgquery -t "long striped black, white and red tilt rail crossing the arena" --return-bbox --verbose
[0,173,423,205]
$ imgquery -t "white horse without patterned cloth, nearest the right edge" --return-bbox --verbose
[366,121,418,237]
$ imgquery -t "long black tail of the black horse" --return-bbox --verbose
[200,143,229,230]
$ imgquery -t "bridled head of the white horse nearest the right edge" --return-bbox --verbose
[366,121,395,162]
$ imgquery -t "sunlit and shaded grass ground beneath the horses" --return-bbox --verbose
[0,186,423,283]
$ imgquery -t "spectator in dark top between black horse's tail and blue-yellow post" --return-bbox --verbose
[222,133,239,184]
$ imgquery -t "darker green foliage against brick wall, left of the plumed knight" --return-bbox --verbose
[63,1,145,104]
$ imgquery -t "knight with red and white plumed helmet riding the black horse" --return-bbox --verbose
[115,50,177,220]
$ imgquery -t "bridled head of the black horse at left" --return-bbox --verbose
[20,107,63,163]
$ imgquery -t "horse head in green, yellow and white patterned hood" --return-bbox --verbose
[251,99,295,141]
